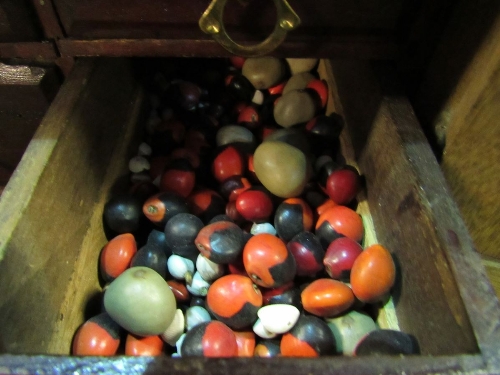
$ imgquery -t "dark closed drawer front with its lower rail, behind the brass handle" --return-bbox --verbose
[52,0,414,59]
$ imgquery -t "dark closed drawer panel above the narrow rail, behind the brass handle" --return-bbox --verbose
[53,0,404,41]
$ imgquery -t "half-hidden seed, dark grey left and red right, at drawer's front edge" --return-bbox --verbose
[181,320,238,357]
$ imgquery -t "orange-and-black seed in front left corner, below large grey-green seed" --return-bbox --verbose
[71,313,121,356]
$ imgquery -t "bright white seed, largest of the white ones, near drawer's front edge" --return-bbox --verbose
[257,304,300,335]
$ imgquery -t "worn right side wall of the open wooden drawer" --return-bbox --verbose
[332,61,500,366]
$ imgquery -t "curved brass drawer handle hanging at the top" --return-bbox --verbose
[198,0,300,57]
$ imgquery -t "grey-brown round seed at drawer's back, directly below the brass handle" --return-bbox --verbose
[241,56,285,90]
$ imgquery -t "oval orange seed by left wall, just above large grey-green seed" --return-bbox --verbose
[99,233,137,283]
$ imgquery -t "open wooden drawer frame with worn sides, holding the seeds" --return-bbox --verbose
[0,59,500,375]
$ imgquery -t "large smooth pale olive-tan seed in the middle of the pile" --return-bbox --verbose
[253,141,310,198]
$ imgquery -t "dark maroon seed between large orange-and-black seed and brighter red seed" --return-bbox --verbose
[286,232,325,277]
